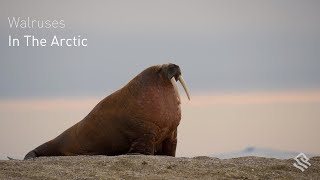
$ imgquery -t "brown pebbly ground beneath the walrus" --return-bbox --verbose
[0,155,320,180]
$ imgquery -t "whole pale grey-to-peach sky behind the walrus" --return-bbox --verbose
[0,0,320,157]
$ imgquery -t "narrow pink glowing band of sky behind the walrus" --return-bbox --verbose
[0,90,320,110]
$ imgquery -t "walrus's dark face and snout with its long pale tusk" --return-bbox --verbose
[163,63,190,101]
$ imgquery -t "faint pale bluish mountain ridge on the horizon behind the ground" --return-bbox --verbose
[210,146,315,159]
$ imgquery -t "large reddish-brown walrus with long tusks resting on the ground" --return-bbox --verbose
[24,63,190,159]
